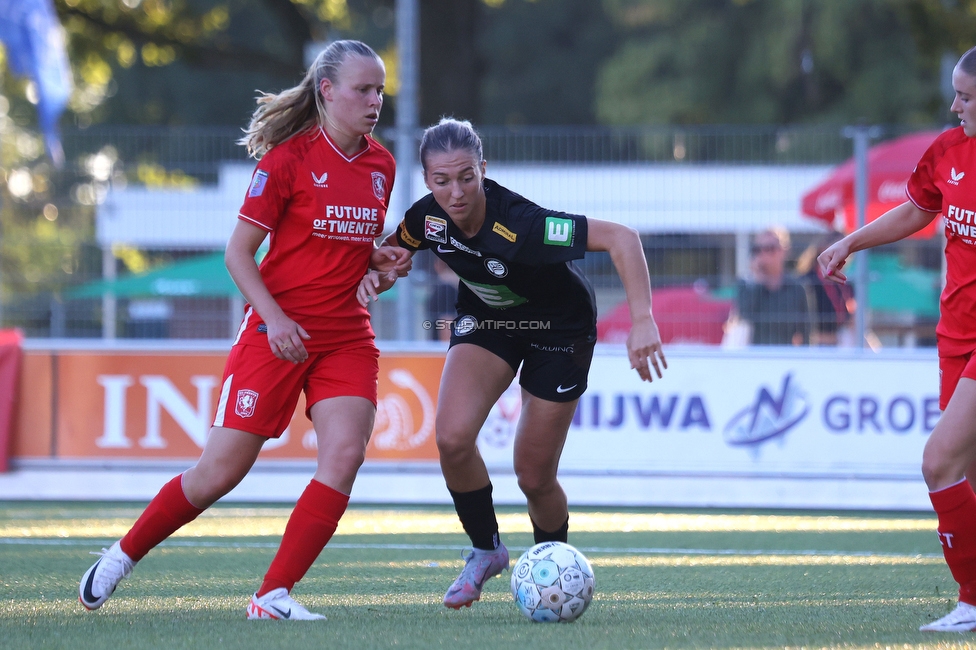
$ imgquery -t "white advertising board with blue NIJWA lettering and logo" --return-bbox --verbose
[479,350,939,509]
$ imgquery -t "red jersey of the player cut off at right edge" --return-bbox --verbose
[908,127,976,357]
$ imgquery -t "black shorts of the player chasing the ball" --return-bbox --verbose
[451,315,596,402]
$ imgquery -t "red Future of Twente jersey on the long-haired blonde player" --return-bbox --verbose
[235,129,396,352]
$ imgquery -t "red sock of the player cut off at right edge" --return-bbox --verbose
[929,479,976,605]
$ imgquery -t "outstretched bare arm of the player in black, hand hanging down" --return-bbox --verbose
[586,219,668,381]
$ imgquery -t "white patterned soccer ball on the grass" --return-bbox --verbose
[512,542,594,623]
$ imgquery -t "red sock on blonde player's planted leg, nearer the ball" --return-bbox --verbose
[257,479,349,596]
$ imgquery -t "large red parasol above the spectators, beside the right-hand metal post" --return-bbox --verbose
[802,131,940,237]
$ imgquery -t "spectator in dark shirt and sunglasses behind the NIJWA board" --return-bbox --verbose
[726,226,811,345]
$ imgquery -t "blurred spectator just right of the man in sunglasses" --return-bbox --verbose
[796,230,854,345]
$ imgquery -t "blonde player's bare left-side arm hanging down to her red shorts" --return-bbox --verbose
[224,220,310,363]
